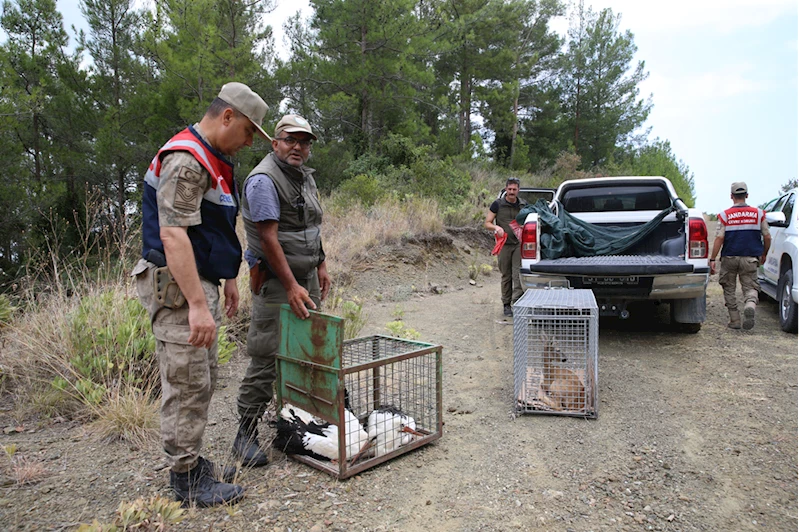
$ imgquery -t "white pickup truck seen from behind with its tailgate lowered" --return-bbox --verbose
[520,176,710,333]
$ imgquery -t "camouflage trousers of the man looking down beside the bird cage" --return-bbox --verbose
[133,260,222,473]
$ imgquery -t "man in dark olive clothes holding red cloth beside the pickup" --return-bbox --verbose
[483,177,527,316]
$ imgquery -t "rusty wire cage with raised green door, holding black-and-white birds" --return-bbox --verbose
[276,305,443,479]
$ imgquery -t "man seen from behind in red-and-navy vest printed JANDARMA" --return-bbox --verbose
[710,181,771,330]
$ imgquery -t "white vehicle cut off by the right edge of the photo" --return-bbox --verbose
[757,189,799,333]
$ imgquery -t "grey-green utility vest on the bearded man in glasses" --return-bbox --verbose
[241,153,325,280]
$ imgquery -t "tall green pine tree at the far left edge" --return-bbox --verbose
[0,0,86,275]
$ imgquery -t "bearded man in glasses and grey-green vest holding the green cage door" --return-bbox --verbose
[233,115,330,466]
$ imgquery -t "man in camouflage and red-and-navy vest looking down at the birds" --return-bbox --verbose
[133,82,268,506]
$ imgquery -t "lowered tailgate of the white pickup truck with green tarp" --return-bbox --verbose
[522,255,694,276]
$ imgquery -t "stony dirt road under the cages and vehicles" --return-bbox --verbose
[0,243,797,532]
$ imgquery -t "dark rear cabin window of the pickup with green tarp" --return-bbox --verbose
[563,185,671,212]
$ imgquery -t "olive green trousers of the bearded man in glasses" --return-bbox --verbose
[238,269,321,418]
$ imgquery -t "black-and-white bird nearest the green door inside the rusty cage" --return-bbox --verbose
[272,404,369,460]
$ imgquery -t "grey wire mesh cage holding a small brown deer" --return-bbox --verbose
[513,288,599,418]
